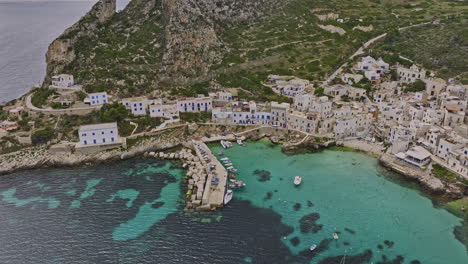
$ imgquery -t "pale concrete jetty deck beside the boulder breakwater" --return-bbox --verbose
[192,140,228,209]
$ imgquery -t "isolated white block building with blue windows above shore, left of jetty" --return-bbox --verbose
[78,123,121,147]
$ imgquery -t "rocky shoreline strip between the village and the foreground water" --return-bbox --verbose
[0,125,465,199]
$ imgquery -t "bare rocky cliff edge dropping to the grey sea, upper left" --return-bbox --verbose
[46,0,117,81]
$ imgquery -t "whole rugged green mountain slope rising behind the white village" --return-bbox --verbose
[46,0,466,99]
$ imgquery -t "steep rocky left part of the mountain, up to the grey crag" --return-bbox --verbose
[46,0,286,91]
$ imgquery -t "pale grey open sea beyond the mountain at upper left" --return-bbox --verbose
[0,0,129,105]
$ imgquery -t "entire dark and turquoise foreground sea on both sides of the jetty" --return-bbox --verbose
[0,142,468,264]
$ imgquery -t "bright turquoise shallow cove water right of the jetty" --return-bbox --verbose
[210,142,468,264]
